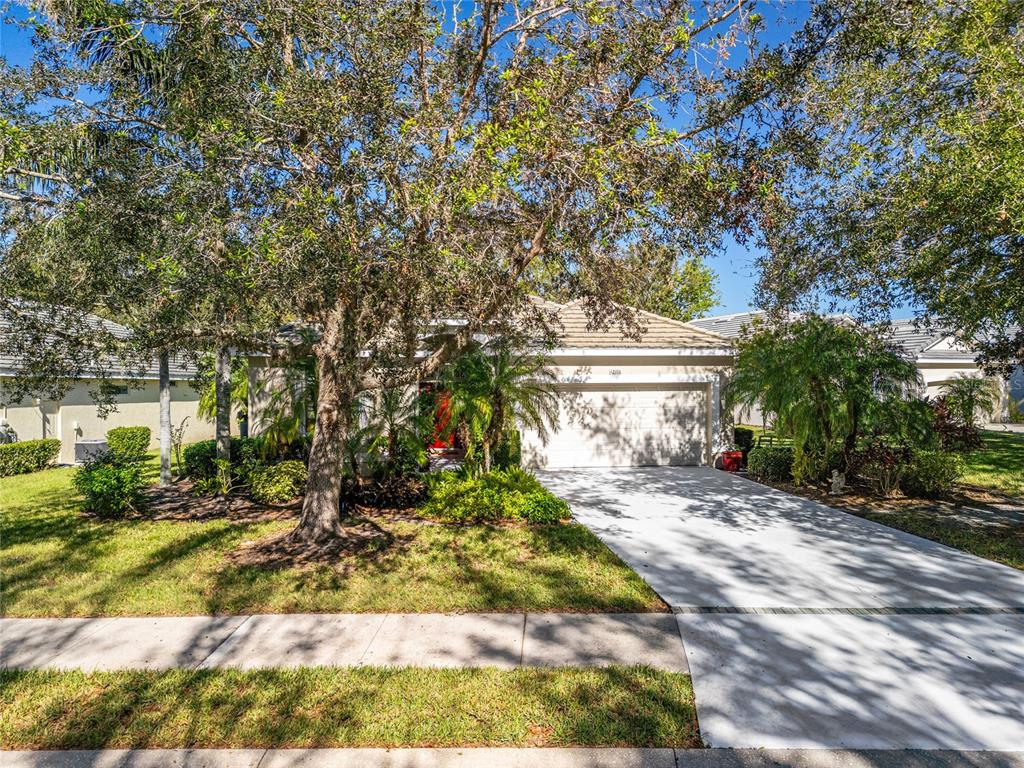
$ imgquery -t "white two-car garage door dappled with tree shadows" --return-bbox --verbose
[522,385,707,467]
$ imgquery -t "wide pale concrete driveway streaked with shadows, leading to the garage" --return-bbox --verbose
[540,467,1024,750]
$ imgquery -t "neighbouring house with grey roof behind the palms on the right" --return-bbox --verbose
[690,312,1024,424]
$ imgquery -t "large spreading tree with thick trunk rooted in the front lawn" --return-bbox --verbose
[2,0,831,543]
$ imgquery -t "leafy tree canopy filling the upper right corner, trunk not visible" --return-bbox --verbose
[761,0,1024,373]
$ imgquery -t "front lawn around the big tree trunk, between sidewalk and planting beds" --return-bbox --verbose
[0,462,665,616]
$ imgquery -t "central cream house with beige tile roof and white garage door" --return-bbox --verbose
[249,302,732,468]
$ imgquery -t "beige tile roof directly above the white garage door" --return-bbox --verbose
[550,301,730,349]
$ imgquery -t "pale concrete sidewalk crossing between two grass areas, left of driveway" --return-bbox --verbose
[0,613,687,672]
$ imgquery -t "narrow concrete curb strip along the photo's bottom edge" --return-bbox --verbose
[0,748,1024,768]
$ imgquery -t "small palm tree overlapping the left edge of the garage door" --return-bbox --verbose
[442,344,558,472]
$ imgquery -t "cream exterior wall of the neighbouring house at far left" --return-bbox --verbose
[0,380,218,464]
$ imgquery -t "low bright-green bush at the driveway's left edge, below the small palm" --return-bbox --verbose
[420,467,569,525]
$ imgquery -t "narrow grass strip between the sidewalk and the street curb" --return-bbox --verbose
[0,667,700,750]
